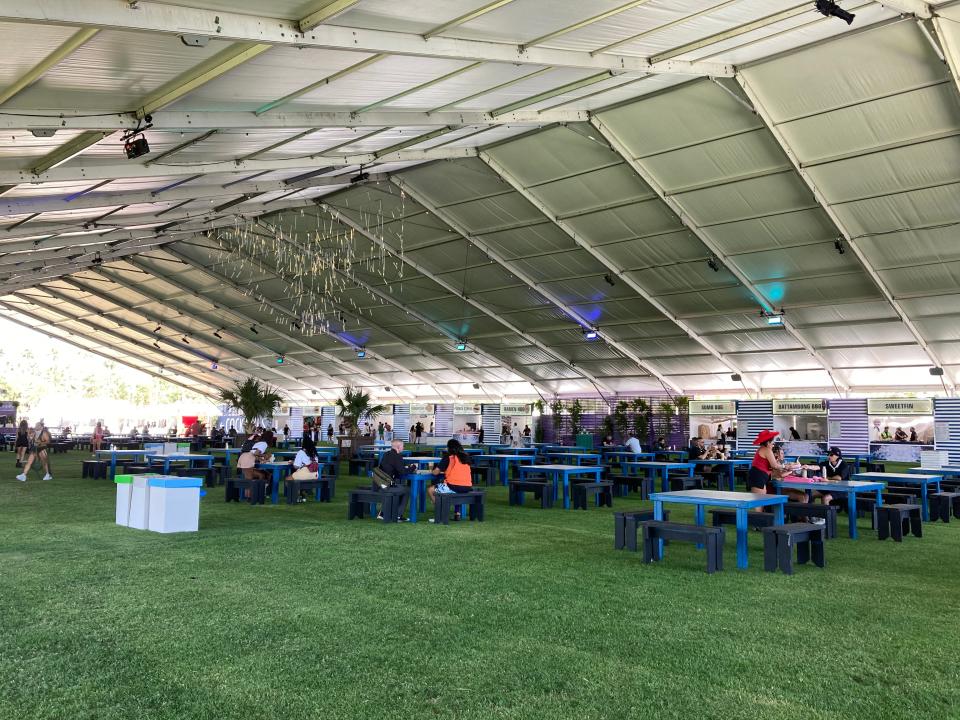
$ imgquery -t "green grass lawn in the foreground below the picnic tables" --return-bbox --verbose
[0,452,960,720]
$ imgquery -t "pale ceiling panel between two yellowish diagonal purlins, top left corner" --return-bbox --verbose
[8,31,229,112]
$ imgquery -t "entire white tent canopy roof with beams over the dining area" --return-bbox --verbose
[0,0,960,403]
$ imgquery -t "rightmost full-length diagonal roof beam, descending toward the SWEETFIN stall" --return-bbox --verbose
[737,74,953,394]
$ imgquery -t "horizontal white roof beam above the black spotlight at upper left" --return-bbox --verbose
[0,109,588,134]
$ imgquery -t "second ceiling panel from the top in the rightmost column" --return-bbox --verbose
[778,79,960,163]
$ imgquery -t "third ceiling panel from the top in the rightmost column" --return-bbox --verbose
[809,137,960,203]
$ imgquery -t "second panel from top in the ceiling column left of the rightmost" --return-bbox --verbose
[643,130,791,192]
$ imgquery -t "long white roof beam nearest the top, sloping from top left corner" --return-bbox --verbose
[0,0,733,77]
